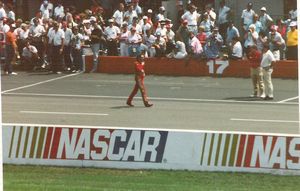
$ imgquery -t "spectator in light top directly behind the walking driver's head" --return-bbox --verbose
[128,27,143,57]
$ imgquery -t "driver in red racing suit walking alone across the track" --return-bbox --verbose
[126,54,153,107]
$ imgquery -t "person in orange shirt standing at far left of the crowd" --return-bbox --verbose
[3,23,18,75]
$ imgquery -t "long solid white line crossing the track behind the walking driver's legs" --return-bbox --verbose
[3,92,298,105]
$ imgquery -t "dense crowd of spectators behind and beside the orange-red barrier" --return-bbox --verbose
[0,0,298,74]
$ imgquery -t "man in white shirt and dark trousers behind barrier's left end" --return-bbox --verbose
[104,19,121,56]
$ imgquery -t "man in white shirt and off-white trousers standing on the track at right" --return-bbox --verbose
[260,45,276,100]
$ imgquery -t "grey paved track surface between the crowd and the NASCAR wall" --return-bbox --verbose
[1,72,299,134]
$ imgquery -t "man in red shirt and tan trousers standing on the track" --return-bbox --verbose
[247,46,264,97]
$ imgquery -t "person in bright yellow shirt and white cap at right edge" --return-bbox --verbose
[286,21,298,60]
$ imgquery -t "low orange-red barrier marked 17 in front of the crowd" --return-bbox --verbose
[85,56,298,79]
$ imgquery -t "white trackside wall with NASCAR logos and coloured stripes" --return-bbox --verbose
[3,124,300,175]
